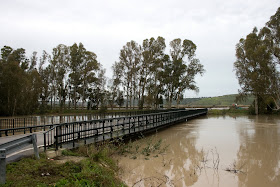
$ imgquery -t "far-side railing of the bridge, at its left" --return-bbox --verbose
[0,109,176,137]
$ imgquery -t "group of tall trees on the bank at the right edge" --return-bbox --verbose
[234,8,280,114]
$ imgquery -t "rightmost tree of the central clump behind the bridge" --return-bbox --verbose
[164,38,205,108]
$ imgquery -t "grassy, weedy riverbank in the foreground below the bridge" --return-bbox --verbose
[0,135,169,187]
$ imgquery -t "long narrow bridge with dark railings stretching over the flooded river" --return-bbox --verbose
[0,109,207,156]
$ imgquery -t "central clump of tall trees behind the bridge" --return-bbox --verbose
[111,36,205,109]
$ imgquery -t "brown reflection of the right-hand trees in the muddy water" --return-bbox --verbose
[237,116,280,186]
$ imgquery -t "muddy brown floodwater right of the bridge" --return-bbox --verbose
[118,116,280,187]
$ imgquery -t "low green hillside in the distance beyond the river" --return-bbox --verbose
[179,94,254,106]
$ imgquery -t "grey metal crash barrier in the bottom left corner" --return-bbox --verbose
[0,134,39,184]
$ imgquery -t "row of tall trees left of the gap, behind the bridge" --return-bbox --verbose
[0,43,105,115]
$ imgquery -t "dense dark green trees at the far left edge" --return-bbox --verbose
[0,46,41,115]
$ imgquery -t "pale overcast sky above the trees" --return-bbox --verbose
[0,0,280,97]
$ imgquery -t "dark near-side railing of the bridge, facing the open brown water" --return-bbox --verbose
[44,109,207,150]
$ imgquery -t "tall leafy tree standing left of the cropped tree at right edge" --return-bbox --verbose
[234,28,274,115]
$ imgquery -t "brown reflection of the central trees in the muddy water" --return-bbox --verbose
[120,123,203,186]
